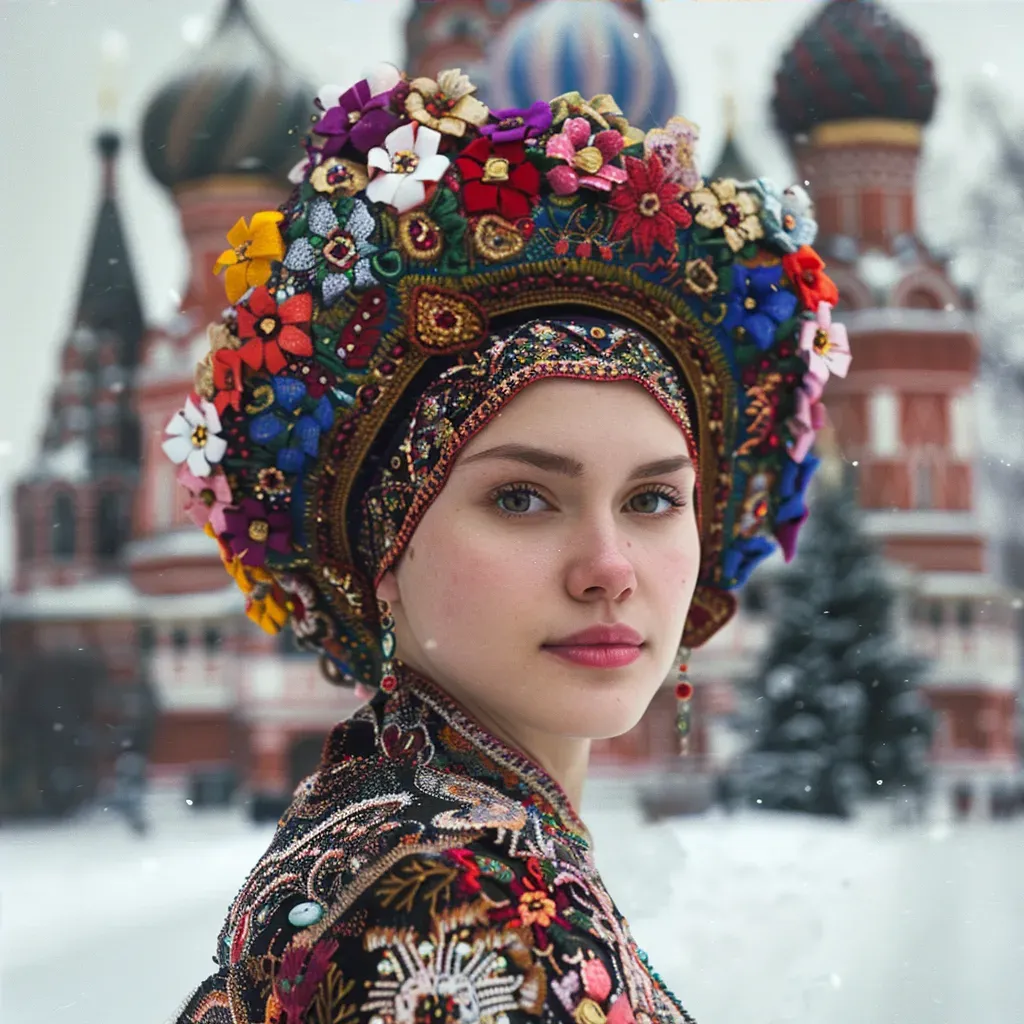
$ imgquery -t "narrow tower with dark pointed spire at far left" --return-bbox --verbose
[14,128,142,592]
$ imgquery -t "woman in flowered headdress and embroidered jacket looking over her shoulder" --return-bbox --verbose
[165,66,849,1024]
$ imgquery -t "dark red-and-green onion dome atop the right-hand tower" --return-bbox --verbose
[772,0,938,136]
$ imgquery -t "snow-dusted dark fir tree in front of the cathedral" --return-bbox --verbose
[748,474,932,815]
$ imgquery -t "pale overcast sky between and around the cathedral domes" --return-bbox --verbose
[0,0,1024,579]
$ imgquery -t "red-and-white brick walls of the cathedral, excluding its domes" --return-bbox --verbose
[4,2,1021,796]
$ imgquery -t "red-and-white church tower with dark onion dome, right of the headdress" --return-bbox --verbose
[773,0,1019,790]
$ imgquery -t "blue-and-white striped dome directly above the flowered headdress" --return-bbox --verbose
[480,0,678,128]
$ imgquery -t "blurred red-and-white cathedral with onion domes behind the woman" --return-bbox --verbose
[2,0,1019,819]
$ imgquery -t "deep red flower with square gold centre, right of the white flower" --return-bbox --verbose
[456,138,541,220]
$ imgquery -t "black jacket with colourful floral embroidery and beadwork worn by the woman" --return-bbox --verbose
[178,669,693,1024]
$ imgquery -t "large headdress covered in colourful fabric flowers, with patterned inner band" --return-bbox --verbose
[164,69,850,685]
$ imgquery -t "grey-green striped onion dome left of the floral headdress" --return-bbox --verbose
[142,0,313,188]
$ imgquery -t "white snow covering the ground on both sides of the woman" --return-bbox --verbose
[0,784,1024,1024]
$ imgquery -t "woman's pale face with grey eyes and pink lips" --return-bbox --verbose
[378,380,699,739]
